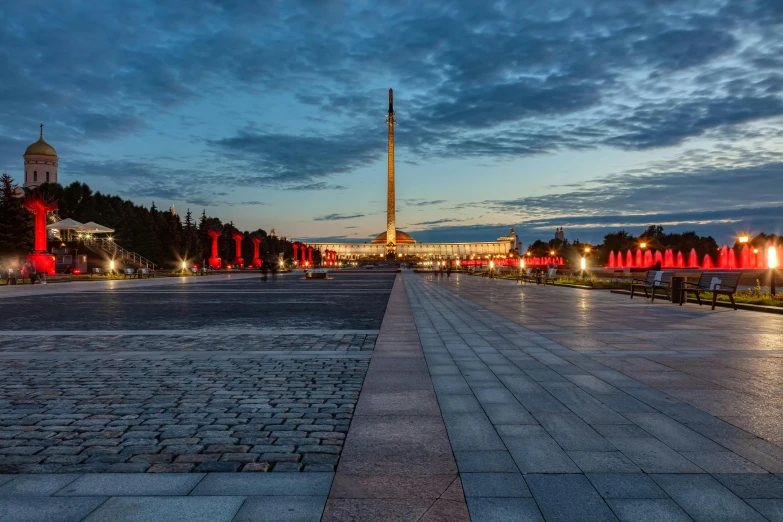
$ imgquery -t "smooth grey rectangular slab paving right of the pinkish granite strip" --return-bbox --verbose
[405,274,783,522]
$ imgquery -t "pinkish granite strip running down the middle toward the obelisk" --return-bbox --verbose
[323,276,468,522]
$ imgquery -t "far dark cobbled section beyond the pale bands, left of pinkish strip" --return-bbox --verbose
[0,272,394,330]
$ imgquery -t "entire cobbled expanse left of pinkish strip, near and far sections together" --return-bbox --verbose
[0,274,394,473]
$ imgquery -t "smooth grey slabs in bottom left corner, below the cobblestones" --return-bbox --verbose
[0,473,333,522]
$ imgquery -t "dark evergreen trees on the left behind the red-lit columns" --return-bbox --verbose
[0,174,320,268]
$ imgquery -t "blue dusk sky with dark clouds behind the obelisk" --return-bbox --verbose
[0,0,783,245]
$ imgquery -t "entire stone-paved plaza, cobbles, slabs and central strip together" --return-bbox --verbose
[0,271,783,522]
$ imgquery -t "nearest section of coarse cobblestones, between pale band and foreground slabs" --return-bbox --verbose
[0,356,369,473]
